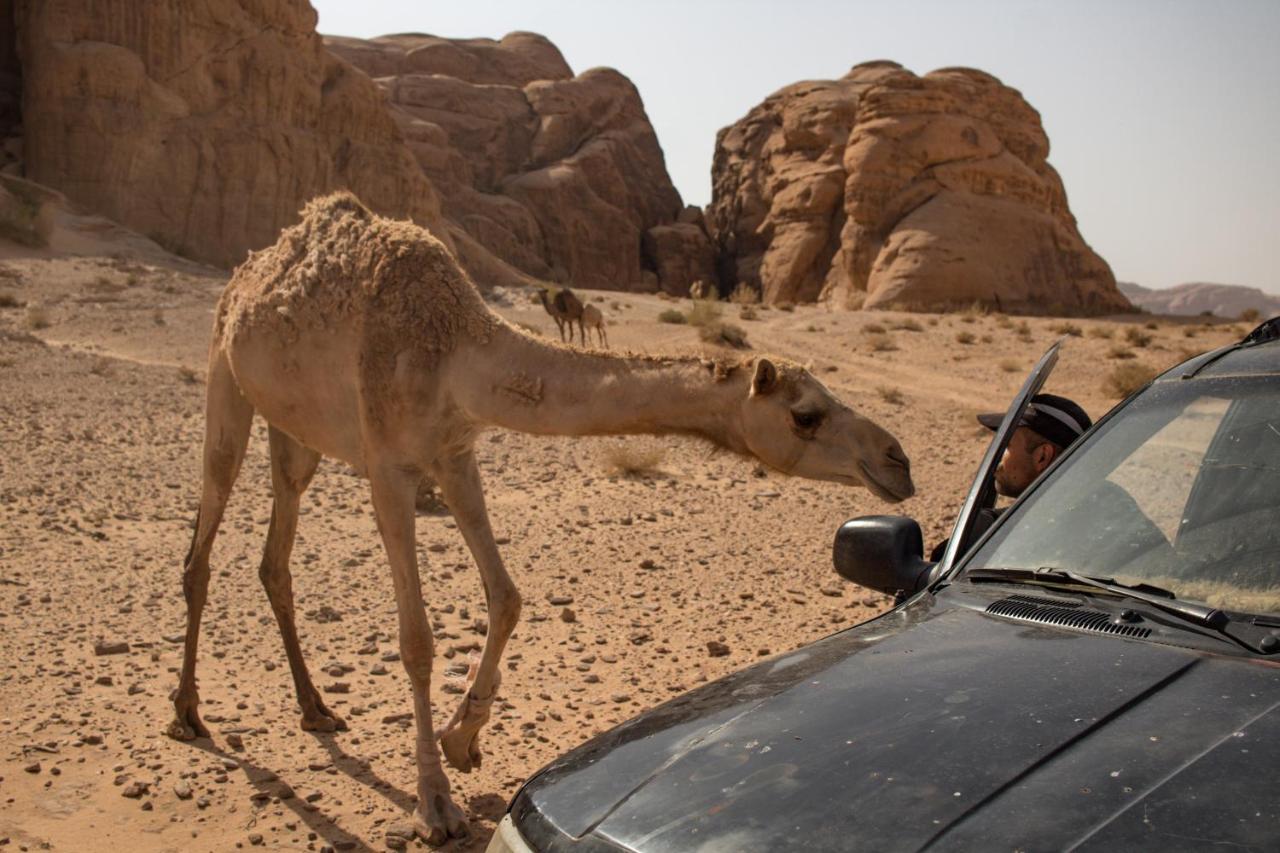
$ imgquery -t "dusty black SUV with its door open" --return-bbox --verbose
[489,318,1280,853]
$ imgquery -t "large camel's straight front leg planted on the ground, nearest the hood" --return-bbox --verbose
[370,466,467,844]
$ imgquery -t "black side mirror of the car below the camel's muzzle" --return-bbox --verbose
[832,515,933,596]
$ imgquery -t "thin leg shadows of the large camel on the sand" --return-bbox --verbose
[189,731,507,853]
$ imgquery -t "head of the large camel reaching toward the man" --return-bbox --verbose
[742,359,915,503]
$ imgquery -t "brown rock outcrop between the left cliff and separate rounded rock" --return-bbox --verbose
[325,33,712,293]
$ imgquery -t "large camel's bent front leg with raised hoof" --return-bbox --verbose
[436,451,520,772]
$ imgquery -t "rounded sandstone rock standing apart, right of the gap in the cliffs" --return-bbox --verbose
[709,61,1130,314]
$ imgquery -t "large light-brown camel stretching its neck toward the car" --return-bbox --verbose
[168,192,914,844]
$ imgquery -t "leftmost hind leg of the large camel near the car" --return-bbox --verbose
[169,352,253,740]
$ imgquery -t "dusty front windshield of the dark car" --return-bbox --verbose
[965,377,1280,613]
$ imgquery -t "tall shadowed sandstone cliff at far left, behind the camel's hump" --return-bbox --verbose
[15,0,449,265]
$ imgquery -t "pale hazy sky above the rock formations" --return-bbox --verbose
[311,0,1280,293]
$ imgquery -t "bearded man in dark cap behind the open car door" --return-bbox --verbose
[929,394,1093,562]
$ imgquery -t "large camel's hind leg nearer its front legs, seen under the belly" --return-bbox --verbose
[259,427,347,731]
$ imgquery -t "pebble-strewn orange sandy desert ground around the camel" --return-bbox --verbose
[0,230,1244,850]
